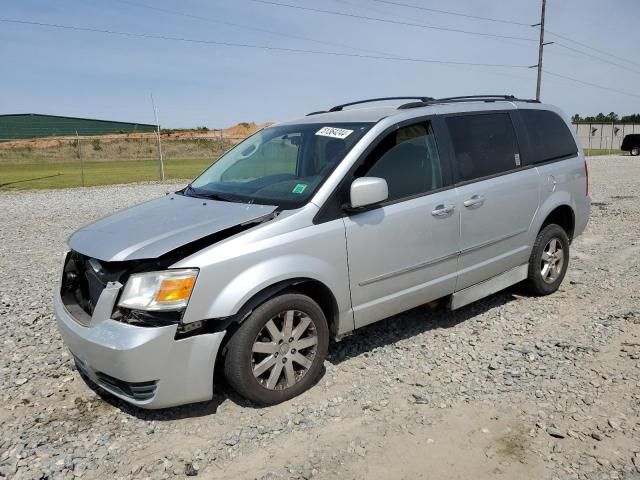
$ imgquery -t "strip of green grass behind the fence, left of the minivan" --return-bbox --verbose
[0,158,212,190]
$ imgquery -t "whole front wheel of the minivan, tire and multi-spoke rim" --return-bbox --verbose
[224,293,329,405]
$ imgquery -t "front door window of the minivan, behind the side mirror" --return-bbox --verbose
[356,123,444,200]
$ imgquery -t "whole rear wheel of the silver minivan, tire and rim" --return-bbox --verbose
[527,223,569,295]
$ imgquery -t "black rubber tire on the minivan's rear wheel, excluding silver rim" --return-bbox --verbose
[527,223,569,295]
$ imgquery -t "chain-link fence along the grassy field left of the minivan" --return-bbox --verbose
[0,131,246,190]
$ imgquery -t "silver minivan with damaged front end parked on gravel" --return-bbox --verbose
[54,96,590,408]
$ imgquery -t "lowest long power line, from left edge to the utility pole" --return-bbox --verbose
[0,18,527,68]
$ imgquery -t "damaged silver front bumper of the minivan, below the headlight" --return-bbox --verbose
[54,294,225,409]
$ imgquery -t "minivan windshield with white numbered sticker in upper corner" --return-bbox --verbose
[182,123,372,209]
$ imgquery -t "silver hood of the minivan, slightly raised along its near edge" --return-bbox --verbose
[69,195,277,262]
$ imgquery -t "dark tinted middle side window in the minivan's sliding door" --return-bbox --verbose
[447,113,520,182]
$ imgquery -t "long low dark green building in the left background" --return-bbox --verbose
[0,113,156,141]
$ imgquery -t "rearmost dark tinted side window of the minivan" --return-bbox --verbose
[520,110,578,163]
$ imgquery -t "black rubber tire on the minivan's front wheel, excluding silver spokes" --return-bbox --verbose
[224,293,329,405]
